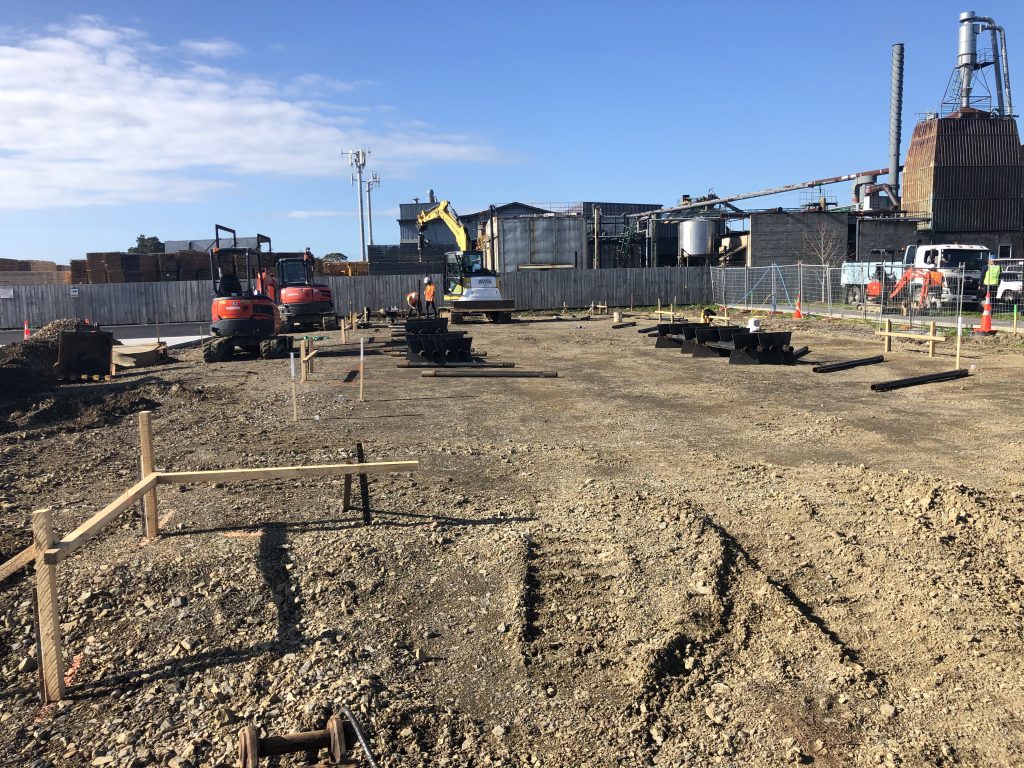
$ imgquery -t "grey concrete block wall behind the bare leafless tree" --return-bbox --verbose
[746,212,849,266]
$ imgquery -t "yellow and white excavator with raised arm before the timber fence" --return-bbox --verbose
[416,200,515,323]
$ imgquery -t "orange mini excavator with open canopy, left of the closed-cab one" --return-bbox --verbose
[203,224,292,362]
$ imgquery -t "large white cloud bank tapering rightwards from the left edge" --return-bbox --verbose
[0,17,501,210]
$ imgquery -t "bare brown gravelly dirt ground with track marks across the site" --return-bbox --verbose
[0,313,1024,768]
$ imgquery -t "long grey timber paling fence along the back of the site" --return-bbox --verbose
[0,267,712,329]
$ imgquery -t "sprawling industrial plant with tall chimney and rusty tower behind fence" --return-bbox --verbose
[358,11,1024,273]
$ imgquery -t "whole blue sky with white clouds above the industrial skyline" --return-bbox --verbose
[0,0,1024,262]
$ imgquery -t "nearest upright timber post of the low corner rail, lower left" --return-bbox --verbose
[32,508,65,703]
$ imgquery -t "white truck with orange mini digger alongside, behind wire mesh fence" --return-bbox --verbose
[842,243,989,309]
